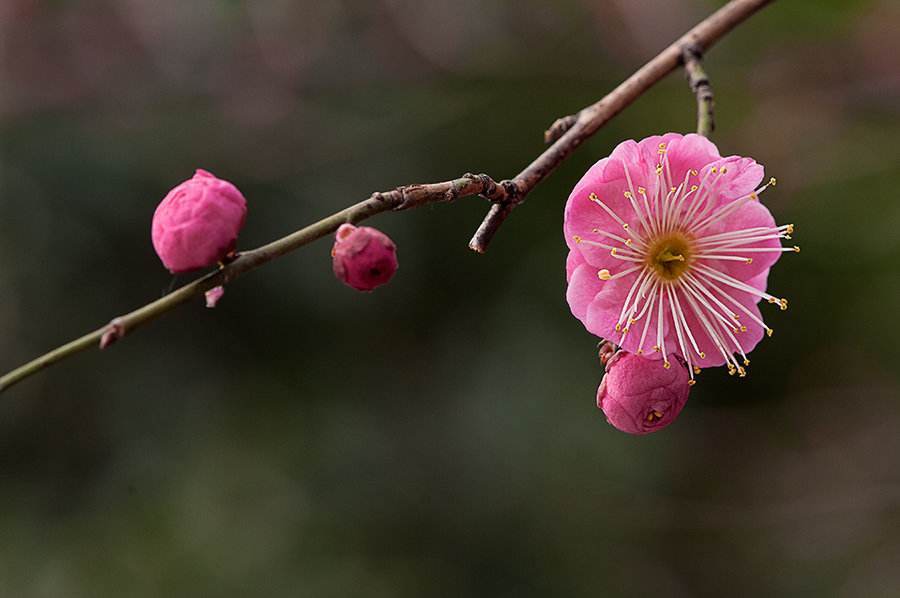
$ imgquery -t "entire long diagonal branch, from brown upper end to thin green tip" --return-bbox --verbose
[0,0,772,392]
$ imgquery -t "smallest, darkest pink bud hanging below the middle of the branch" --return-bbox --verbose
[331,224,397,291]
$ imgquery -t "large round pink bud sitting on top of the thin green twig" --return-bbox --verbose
[151,169,247,274]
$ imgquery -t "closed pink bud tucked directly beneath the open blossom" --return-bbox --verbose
[597,350,691,434]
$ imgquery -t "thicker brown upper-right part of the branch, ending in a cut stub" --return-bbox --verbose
[469,0,772,253]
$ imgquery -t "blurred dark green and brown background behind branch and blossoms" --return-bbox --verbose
[0,0,900,597]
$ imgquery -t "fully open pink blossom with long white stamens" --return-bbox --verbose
[563,133,800,381]
